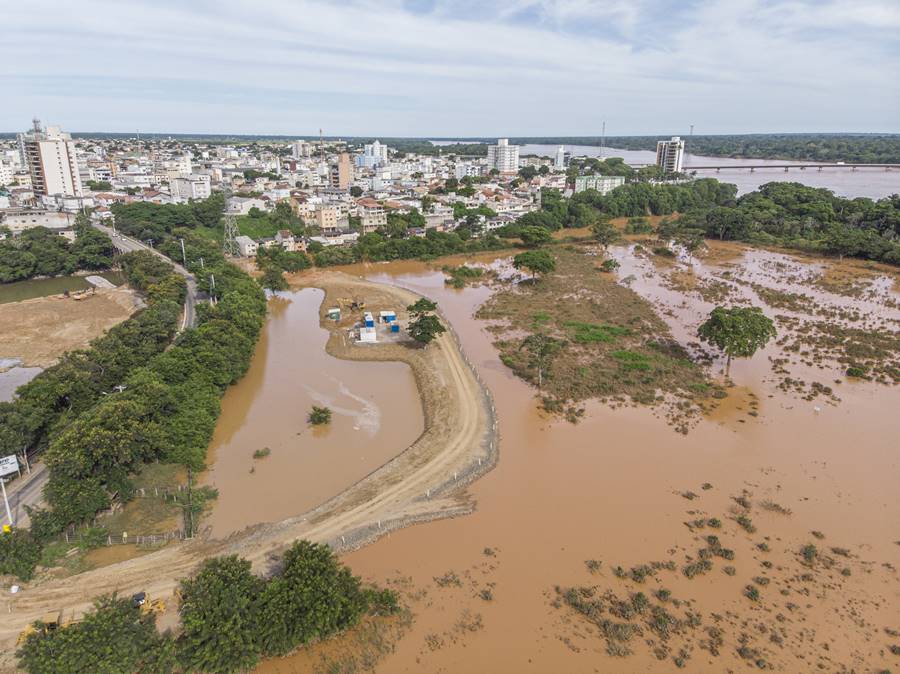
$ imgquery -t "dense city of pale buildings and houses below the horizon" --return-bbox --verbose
[0,125,624,247]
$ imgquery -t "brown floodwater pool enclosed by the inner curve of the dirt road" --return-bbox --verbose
[204,288,423,537]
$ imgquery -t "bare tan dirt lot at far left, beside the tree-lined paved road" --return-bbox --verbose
[0,287,141,367]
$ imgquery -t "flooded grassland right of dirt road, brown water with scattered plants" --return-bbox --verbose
[262,244,900,672]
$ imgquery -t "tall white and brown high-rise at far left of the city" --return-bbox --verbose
[19,119,84,197]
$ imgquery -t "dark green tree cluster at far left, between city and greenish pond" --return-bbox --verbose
[0,214,114,283]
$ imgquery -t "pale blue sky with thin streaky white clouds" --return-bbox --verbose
[0,0,900,136]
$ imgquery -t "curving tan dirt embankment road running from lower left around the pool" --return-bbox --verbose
[0,271,497,668]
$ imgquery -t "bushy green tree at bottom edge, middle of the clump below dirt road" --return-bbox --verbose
[178,555,264,673]
